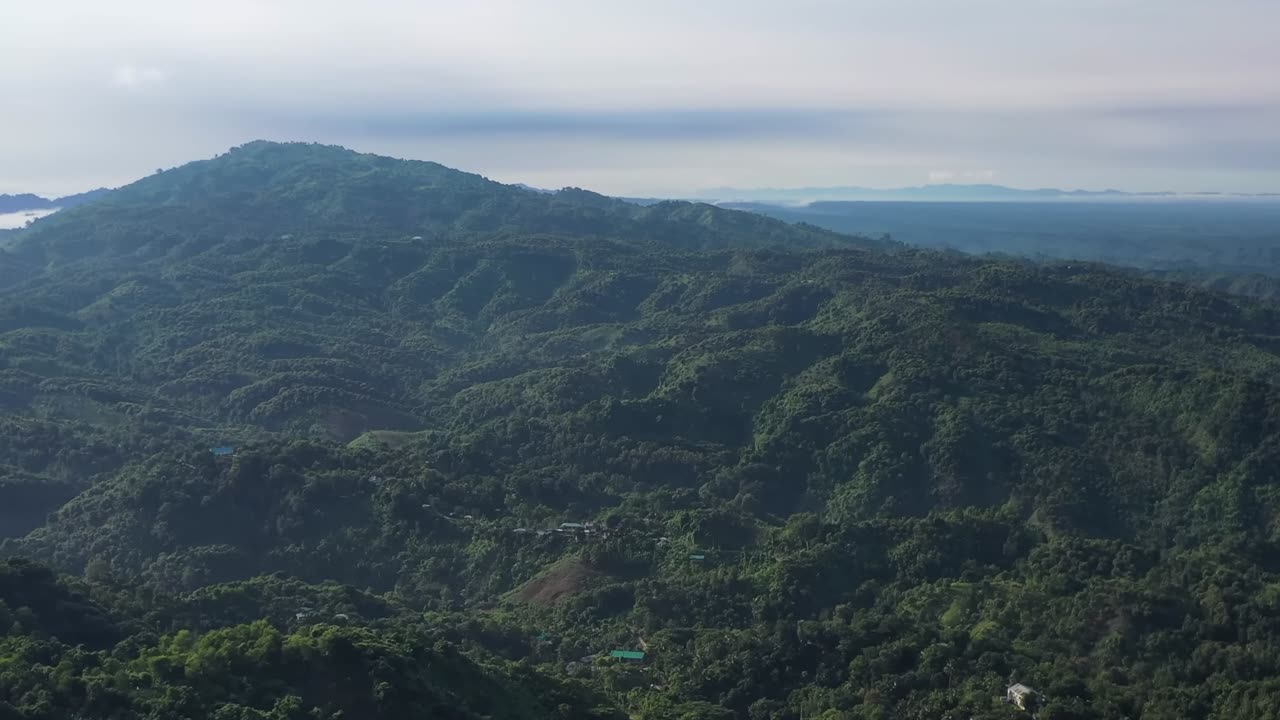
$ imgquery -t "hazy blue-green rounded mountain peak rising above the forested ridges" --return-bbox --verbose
[9,142,858,264]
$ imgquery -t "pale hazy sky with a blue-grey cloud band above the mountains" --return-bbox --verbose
[0,0,1280,195]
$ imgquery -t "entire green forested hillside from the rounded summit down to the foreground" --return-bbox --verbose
[0,143,1280,720]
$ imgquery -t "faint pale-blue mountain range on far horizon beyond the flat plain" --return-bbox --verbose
[696,184,1280,205]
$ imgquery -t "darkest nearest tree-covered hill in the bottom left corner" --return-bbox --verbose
[0,561,618,720]
